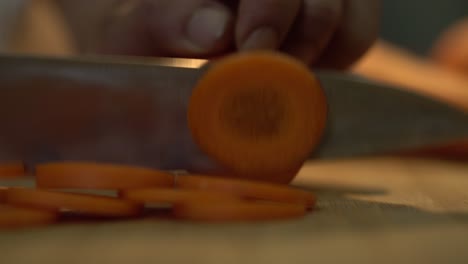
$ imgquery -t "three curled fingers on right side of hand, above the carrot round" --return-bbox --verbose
[236,0,381,69]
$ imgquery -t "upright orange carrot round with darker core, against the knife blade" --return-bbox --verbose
[188,51,327,183]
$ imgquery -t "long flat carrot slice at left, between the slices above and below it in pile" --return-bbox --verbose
[6,188,142,217]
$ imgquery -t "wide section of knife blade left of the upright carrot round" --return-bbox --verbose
[0,55,211,169]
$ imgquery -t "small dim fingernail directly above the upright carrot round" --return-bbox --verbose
[240,27,279,50]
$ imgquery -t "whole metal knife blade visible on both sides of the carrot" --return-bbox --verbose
[0,54,468,170]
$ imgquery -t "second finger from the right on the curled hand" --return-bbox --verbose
[283,0,343,64]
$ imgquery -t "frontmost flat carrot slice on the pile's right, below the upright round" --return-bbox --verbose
[173,199,306,222]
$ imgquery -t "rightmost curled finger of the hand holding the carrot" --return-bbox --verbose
[316,0,381,69]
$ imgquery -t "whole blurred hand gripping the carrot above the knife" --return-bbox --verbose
[62,0,380,68]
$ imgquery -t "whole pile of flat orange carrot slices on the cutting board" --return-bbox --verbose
[0,162,316,228]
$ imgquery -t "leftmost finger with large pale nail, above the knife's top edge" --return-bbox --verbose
[103,0,233,57]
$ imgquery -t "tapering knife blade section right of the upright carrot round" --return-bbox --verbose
[313,72,468,159]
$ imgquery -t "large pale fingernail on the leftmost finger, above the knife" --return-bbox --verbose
[187,7,230,51]
